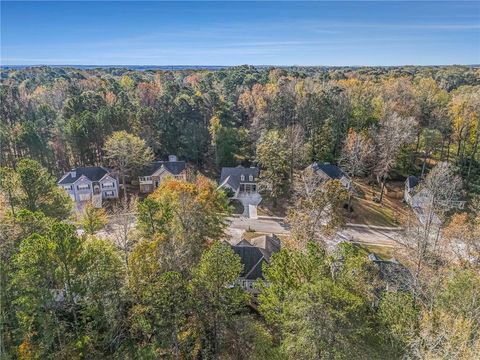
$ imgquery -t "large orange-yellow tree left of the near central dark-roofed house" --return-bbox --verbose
[138,176,231,270]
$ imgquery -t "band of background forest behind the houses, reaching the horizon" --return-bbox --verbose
[0,66,480,193]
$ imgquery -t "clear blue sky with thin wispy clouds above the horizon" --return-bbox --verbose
[1,1,480,65]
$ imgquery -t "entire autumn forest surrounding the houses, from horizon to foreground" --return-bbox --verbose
[0,66,480,360]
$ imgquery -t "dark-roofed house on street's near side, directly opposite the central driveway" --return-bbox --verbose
[232,234,280,294]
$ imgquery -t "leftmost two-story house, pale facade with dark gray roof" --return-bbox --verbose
[57,166,118,207]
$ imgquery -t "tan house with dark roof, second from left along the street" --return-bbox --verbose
[138,155,187,194]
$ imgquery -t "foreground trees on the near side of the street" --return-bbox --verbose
[0,159,480,360]
